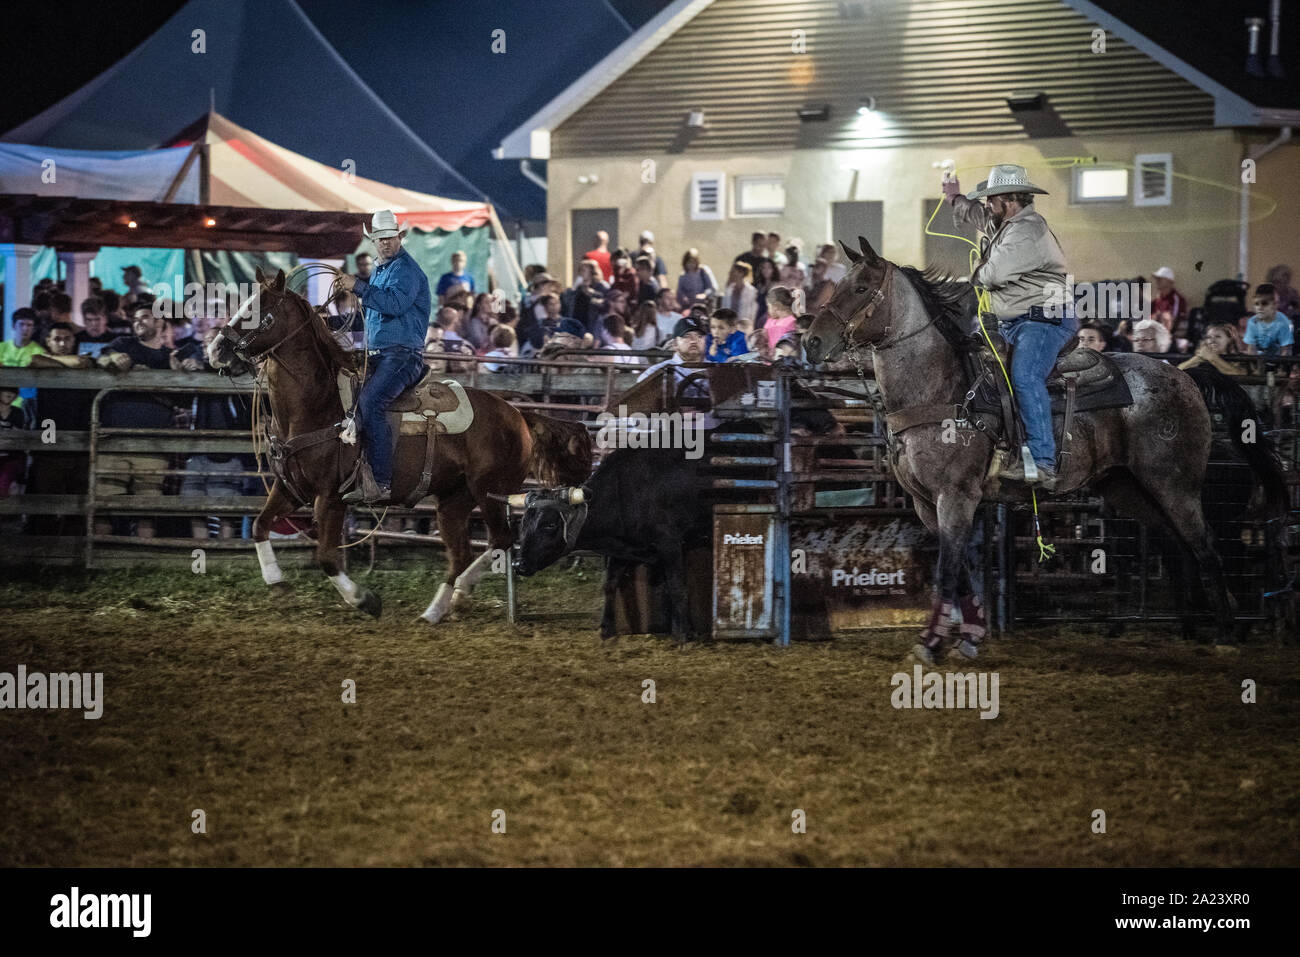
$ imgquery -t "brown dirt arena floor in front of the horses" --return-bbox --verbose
[0,557,1300,866]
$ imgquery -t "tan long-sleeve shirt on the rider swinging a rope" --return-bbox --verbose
[953,195,1066,320]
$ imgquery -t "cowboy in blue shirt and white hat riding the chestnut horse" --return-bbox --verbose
[339,209,433,505]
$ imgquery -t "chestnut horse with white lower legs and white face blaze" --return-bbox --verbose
[208,270,592,624]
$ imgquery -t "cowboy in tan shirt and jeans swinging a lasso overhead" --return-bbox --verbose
[943,164,1078,492]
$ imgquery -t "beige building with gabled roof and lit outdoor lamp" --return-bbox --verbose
[499,0,1300,295]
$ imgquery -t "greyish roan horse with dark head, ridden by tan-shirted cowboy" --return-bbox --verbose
[803,237,1279,663]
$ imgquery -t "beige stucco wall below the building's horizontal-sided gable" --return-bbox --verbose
[547,130,1248,296]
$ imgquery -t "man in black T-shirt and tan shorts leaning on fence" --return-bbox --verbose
[95,303,174,538]
